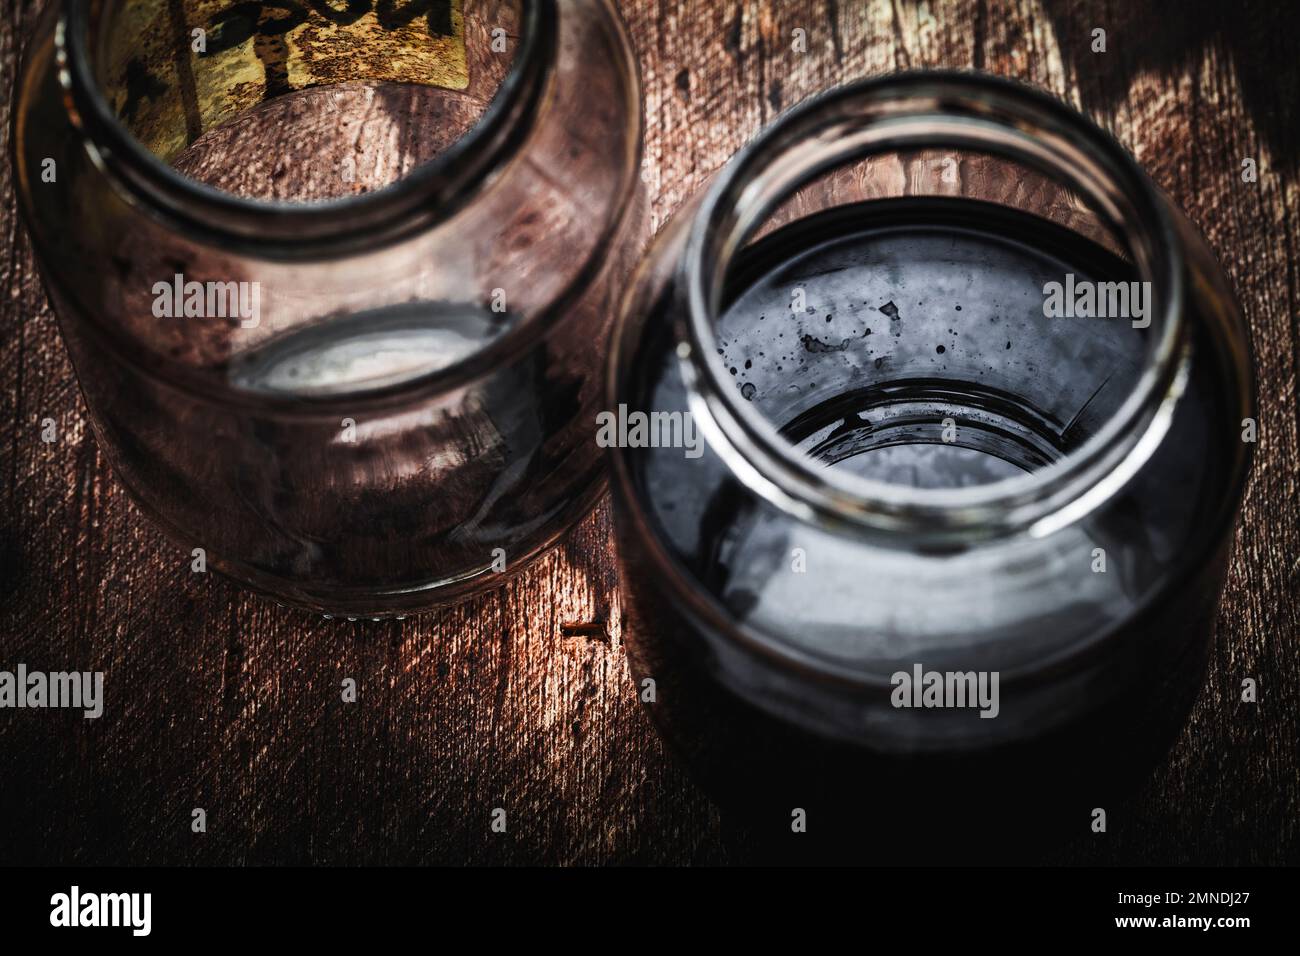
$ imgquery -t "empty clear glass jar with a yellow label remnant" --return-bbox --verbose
[12,0,641,615]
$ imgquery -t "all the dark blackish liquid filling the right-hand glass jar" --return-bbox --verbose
[616,199,1236,862]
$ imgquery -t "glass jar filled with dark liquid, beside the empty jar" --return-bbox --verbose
[605,72,1255,860]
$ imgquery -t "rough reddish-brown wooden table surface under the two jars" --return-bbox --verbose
[0,0,1300,864]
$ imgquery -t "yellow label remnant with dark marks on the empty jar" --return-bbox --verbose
[99,0,469,160]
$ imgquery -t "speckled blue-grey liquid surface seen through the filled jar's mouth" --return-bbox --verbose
[718,201,1145,488]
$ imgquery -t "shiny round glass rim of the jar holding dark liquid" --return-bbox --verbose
[677,70,1188,541]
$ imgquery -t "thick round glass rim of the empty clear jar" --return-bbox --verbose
[55,0,556,260]
